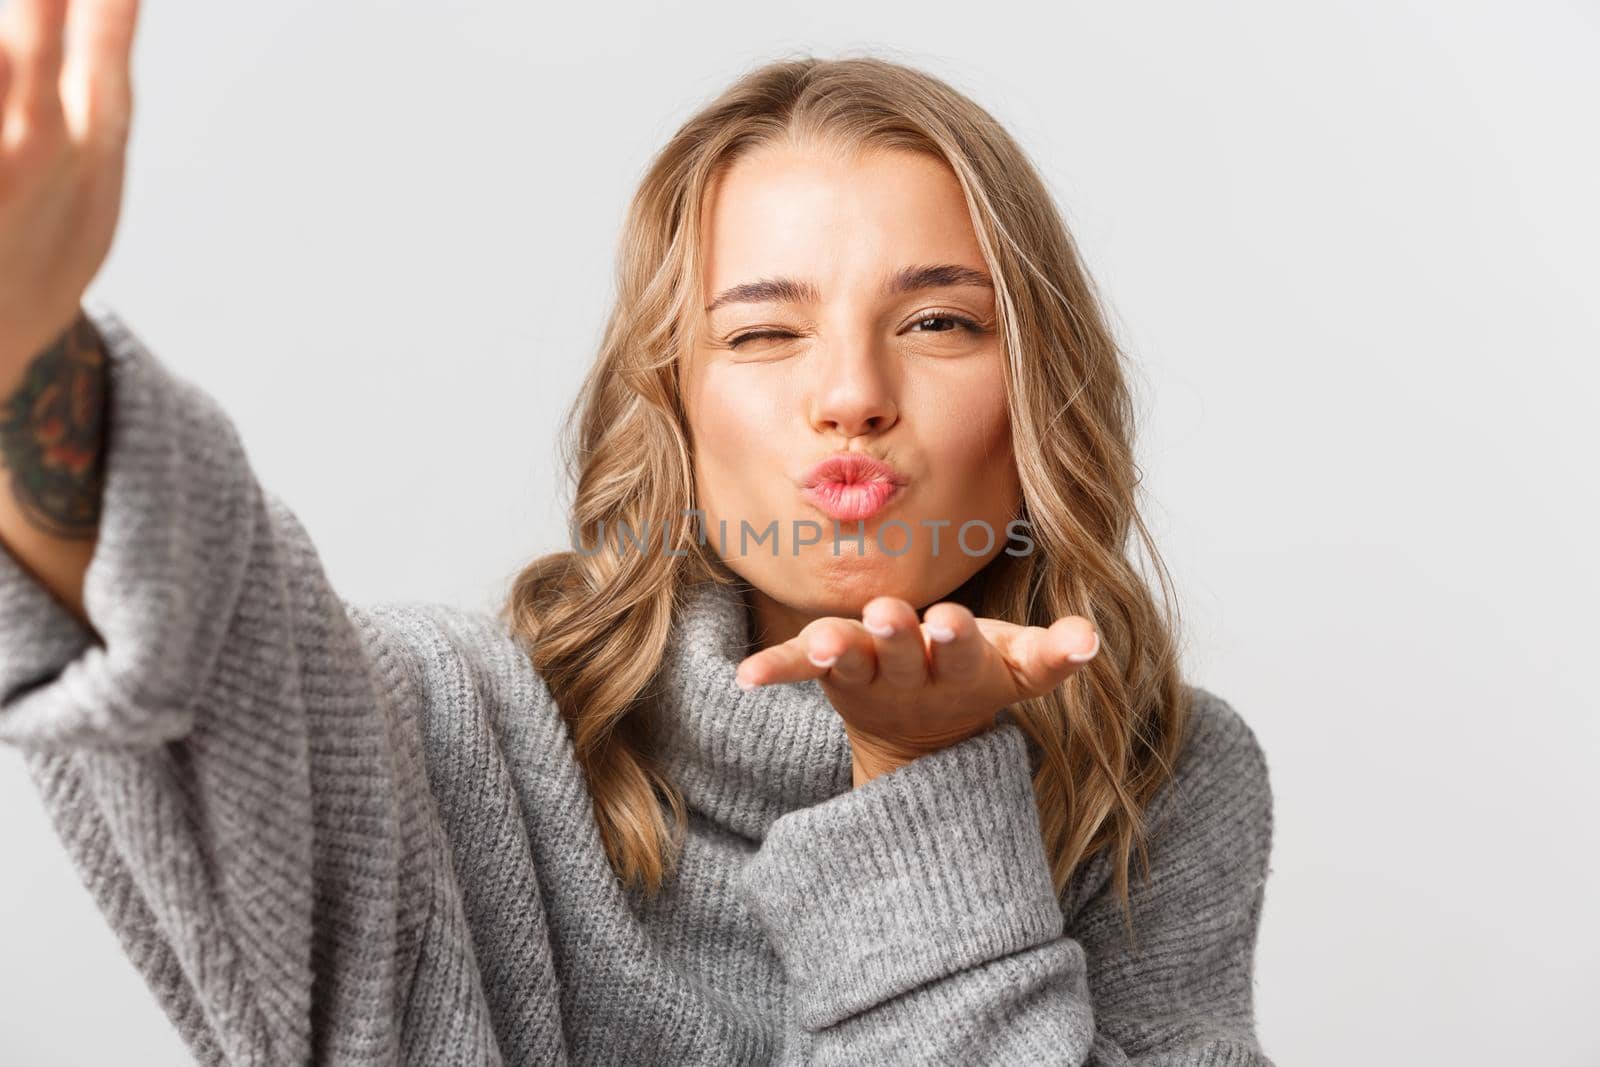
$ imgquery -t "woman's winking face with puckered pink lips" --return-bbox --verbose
[680,146,1021,648]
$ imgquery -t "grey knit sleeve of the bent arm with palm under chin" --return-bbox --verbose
[741,687,1270,1067]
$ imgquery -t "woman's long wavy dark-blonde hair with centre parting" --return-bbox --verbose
[502,49,1189,933]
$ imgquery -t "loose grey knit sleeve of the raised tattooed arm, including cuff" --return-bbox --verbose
[0,304,430,1064]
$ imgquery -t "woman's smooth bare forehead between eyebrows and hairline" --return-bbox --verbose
[701,144,984,296]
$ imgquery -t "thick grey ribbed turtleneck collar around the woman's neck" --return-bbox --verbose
[656,581,853,841]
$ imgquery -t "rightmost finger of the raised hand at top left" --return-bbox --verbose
[61,0,139,146]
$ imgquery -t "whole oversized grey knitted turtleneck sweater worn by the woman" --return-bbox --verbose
[0,304,1272,1065]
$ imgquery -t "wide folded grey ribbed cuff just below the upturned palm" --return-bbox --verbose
[739,721,1064,1030]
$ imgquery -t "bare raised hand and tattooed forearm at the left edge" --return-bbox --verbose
[0,0,138,633]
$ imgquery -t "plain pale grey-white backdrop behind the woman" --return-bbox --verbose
[0,0,1600,1067]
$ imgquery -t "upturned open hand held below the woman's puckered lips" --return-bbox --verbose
[736,597,1099,785]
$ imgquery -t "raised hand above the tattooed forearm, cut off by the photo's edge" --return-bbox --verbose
[0,0,139,375]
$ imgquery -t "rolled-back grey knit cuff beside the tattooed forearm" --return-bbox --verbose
[0,299,252,749]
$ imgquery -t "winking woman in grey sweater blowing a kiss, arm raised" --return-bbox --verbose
[0,0,1270,1064]
